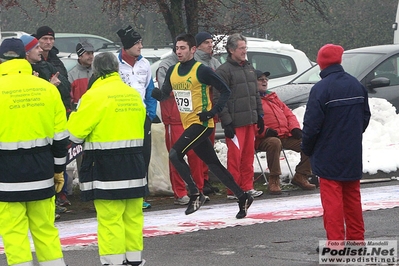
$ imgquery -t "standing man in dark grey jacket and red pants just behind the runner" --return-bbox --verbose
[214,33,265,199]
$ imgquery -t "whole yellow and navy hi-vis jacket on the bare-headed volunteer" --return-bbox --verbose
[67,72,148,201]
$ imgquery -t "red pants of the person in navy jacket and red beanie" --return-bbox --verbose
[320,178,364,240]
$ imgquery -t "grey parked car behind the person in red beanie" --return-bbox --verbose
[271,44,399,113]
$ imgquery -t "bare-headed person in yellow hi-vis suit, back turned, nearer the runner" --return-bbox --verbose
[67,53,147,266]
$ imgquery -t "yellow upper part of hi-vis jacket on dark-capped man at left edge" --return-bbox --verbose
[0,59,68,150]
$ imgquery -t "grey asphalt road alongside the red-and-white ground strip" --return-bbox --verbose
[0,181,399,266]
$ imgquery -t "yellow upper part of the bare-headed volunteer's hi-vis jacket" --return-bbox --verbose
[67,72,146,150]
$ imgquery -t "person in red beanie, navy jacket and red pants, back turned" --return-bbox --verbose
[302,44,371,243]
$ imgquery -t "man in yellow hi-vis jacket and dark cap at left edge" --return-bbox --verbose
[0,38,68,266]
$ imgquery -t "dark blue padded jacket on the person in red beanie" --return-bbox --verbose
[302,64,371,181]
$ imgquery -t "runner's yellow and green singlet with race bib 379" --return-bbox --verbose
[170,62,215,129]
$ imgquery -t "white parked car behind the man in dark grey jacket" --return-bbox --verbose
[214,37,314,88]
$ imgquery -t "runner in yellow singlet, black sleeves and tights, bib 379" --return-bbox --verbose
[152,34,253,219]
